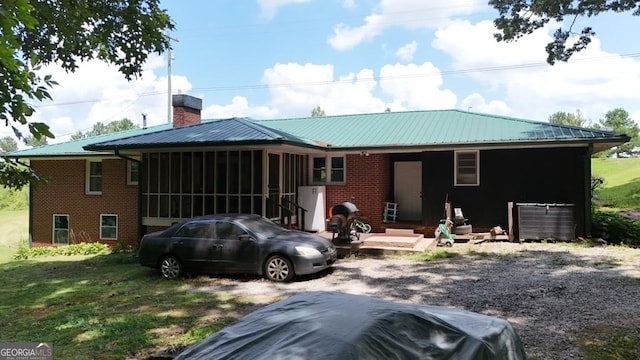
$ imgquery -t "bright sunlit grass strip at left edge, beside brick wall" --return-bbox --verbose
[0,209,29,264]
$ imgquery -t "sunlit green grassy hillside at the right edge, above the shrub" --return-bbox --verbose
[591,158,640,210]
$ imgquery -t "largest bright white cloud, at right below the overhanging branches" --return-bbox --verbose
[433,21,640,120]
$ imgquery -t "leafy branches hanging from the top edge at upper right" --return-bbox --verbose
[489,0,640,65]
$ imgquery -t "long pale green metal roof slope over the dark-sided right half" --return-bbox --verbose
[256,110,628,148]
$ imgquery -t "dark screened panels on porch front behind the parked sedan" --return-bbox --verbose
[142,150,264,222]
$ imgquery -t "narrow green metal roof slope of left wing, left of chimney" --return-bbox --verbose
[3,124,172,158]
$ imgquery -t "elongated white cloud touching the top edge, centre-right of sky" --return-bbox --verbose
[328,0,488,51]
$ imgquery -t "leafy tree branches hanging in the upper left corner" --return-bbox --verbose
[0,0,174,187]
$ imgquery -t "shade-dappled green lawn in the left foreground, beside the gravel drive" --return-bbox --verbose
[0,254,256,359]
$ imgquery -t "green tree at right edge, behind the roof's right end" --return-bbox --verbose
[594,108,640,157]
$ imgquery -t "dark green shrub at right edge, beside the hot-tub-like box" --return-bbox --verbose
[591,210,640,247]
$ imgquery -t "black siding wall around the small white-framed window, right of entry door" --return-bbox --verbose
[422,148,589,236]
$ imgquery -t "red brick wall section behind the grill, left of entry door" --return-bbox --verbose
[326,154,391,232]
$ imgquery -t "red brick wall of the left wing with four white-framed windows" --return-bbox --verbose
[31,159,138,246]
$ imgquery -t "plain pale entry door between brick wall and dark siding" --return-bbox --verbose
[393,161,422,221]
